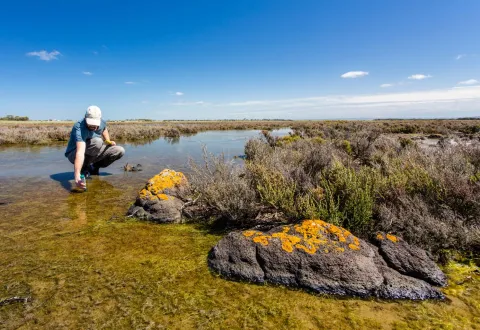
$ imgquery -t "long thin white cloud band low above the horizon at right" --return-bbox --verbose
[200,86,480,119]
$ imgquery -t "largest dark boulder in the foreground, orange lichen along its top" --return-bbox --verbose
[208,220,443,300]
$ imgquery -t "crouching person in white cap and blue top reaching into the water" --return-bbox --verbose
[65,105,125,188]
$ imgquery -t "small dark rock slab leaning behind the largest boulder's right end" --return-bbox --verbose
[375,233,447,286]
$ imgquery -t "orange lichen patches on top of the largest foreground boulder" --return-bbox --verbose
[243,220,360,254]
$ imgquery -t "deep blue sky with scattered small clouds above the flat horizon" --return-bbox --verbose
[0,0,480,120]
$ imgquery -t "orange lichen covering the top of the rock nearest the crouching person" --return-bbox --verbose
[138,169,187,200]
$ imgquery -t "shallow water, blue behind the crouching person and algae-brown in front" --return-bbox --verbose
[0,131,480,329]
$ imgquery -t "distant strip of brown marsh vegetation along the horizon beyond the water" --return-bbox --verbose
[0,120,480,145]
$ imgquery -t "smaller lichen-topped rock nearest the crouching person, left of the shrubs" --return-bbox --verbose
[127,169,188,223]
